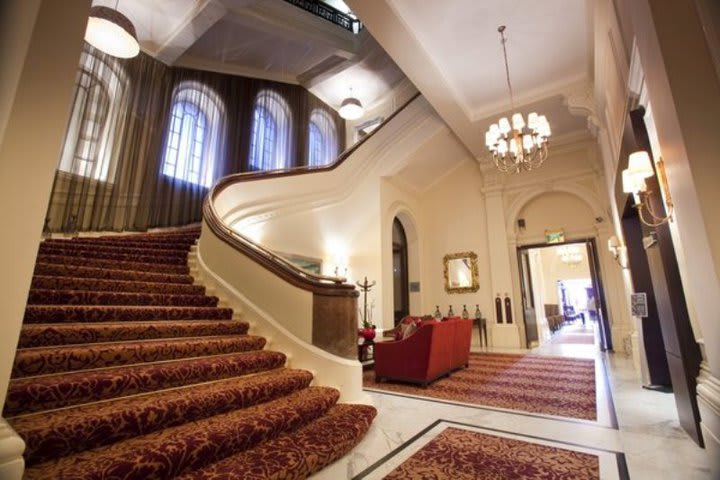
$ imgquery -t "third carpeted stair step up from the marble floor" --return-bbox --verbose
[9,368,313,465]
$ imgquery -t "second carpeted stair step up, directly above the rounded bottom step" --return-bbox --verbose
[25,387,339,479]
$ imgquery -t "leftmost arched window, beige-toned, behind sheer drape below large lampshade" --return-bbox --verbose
[59,51,127,181]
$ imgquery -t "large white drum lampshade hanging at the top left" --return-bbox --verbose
[85,5,140,58]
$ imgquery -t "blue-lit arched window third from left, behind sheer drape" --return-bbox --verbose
[250,90,291,170]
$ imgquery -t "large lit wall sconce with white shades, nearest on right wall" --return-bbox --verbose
[622,150,673,227]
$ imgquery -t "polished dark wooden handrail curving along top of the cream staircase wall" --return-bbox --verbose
[203,93,420,297]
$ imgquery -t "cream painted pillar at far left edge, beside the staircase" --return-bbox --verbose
[0,0,90,404]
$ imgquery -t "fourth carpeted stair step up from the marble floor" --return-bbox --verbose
[3,350,286,418]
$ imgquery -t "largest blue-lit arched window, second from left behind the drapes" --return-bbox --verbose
[162,81,223,187]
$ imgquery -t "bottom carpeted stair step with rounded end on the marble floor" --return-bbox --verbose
[175,404,377,480]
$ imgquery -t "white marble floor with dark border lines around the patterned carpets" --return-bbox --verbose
[311,322,711,480]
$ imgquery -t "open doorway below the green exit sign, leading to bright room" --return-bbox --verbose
[518,239,612,351]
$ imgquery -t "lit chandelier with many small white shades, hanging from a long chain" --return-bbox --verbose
[485,25,551,173]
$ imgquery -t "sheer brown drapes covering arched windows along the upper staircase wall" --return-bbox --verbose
[46,44,344,232]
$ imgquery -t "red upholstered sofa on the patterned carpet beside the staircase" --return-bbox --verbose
[375,318,472,386]
